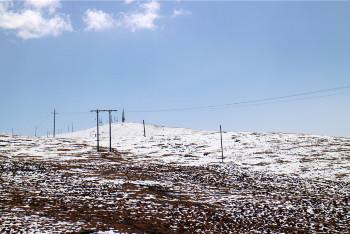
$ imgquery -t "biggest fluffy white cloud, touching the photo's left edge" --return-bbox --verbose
[0,0,73,39]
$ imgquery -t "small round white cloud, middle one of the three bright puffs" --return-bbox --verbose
[83,9,115,31]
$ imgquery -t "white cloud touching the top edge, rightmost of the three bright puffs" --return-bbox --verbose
[120,1,160,31]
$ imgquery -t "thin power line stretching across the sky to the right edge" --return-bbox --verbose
[129,86,350,113]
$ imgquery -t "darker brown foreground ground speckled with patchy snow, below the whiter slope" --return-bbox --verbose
[0,133,350,233]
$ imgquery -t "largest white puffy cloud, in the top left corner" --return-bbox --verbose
[0,0,73,39]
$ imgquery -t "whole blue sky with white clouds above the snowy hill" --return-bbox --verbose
[0,0,350,136]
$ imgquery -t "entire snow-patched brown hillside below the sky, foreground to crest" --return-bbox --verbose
[0,123,350,233]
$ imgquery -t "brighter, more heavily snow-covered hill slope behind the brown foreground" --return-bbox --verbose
[59,123,350,181]
